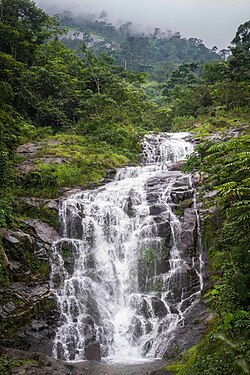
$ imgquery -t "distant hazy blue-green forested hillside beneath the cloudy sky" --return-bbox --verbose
[60,11,222,82]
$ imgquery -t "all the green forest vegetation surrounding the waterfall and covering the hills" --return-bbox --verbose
[0,0,250,375]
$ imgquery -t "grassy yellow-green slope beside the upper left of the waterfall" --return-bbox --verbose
[21,134,136,197]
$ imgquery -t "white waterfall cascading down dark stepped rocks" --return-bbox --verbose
[52,133,202,361]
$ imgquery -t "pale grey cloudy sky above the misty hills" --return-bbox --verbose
[36,0,250,49]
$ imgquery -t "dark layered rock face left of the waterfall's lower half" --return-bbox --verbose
[0,214,59,355]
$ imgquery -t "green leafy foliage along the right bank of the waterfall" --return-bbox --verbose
[180,134,250,375]
